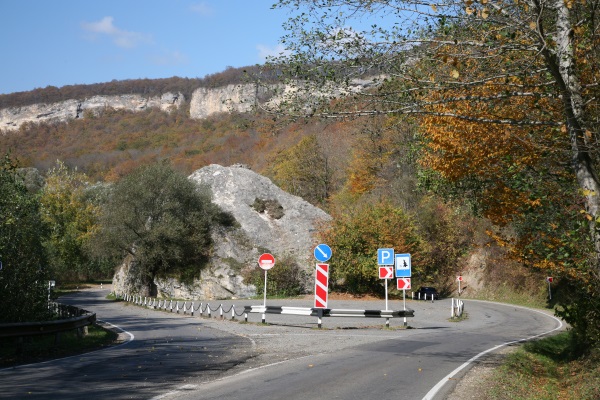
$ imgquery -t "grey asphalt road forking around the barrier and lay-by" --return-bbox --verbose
[0,291,560,400]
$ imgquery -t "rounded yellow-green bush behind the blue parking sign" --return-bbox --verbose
[320,202,423,294]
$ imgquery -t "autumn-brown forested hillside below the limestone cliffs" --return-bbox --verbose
[0,70,544,306]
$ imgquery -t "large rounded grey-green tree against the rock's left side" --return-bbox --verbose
[96,163,234,294]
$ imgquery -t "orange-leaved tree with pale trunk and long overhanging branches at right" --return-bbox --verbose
[274,0,600,344]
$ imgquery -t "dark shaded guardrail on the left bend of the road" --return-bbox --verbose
[0,303,96,343]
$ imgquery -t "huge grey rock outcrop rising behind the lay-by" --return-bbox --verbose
[113,165,330,299]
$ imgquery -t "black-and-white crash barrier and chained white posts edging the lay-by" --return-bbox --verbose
[115,294,414,328]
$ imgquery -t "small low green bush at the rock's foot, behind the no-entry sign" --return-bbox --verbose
[243,256,308,297]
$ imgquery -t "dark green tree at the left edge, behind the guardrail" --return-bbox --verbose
[0,156,48,322]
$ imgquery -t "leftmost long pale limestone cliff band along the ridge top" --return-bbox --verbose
[0,93,185,132]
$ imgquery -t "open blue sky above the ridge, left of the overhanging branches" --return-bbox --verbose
[0,0,289,94]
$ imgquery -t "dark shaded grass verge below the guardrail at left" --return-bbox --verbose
[0,325,118,368]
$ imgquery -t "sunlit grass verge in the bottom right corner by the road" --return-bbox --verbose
[485,332,600,400]
